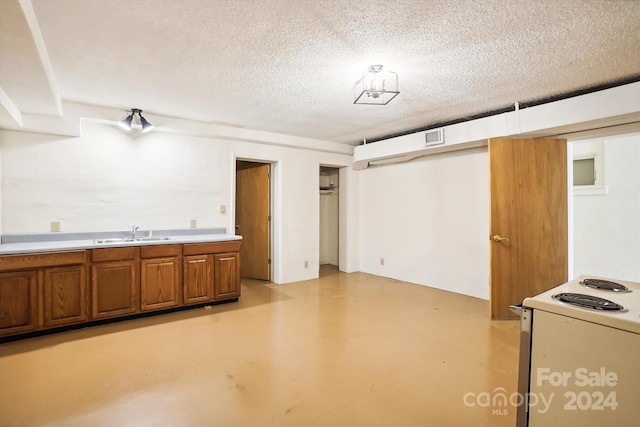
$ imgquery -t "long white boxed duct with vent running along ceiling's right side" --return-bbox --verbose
[354,82,640,169]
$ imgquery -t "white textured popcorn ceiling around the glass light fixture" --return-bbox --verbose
[0,0,640,145]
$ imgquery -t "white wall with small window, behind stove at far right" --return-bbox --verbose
[573,133,640,281]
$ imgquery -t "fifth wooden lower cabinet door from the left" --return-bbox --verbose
[183,255,213,304]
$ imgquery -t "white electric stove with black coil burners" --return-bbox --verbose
[517,276,640,427]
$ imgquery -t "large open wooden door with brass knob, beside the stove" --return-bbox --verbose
[489,138,568,319]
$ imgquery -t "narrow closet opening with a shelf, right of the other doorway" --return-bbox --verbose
[319,166,340,268]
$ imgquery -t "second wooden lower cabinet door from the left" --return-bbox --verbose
[44,265,88,326]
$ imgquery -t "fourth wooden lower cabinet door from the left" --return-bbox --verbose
[140,258,182,311]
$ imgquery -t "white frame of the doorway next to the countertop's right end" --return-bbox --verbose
[227,153,282,283]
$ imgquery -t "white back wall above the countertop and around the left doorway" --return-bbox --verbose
[0,122,353,283]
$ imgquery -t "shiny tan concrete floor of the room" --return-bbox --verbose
[0,267,519,427]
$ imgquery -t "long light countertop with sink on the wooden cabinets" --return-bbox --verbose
[0,233,242,255]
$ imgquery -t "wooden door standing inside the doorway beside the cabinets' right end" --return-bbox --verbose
[236,162,271,280]
